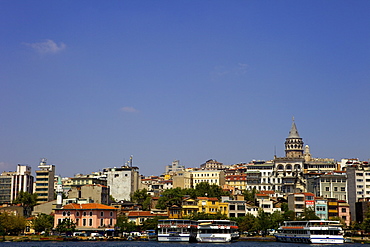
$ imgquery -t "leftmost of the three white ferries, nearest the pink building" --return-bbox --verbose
[157,219,197,242]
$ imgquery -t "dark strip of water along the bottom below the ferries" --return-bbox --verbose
[0,241,365,247]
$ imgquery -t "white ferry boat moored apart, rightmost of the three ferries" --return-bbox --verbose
[275,220,344,244]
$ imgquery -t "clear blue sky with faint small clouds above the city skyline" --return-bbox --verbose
[0,0,370,176]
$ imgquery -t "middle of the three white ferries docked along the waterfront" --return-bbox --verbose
[196,220,239,243]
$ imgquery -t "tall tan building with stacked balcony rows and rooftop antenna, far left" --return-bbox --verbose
[35,158,55,203]
